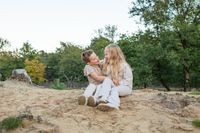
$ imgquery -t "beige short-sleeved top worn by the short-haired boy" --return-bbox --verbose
[84,65,102,85]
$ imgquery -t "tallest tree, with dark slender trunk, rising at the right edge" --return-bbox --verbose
[130,0,200,91]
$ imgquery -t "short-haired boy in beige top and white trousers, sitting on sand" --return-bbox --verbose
[78,50,105,107]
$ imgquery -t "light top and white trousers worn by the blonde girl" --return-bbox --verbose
[95,63,133,108]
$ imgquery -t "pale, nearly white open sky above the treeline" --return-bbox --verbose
[0,0,140,52]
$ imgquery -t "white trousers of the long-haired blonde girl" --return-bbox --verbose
[94,78,132,108]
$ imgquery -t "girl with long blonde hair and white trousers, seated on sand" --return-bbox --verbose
[96,44,133,111]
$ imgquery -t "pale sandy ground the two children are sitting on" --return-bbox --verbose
[0,81,200,133]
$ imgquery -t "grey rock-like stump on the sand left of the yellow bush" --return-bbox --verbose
[11,69,32,84]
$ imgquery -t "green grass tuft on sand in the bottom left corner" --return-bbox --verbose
[0,117,22,130]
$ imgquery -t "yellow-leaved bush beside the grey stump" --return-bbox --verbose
[24,59,45,83]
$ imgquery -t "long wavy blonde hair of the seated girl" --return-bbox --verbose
[103,44,126,79]
